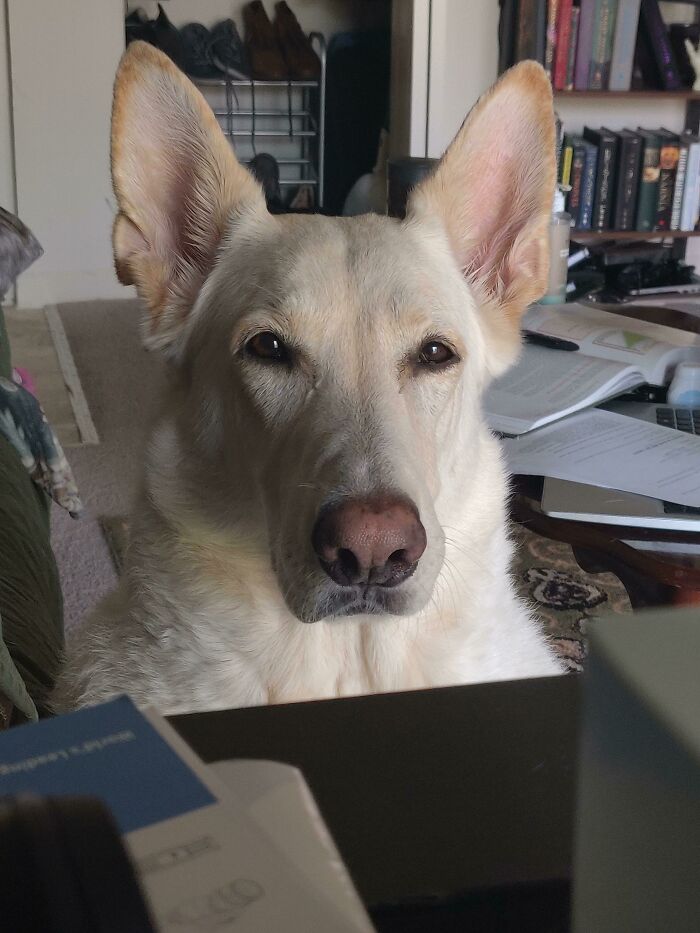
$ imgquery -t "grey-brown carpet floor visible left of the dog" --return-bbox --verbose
[47,301,164,628]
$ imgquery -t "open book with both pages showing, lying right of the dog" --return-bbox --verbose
[484,303,700,434]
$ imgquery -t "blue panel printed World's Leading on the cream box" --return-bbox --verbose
[0,697,216,833]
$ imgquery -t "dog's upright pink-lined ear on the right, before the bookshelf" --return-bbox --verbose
[409,61,556,329]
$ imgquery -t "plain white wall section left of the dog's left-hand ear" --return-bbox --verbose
[8,0,127,307]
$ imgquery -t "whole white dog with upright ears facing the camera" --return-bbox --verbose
[56,43,561,713]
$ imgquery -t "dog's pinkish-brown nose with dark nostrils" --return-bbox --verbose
[311,495,426,586]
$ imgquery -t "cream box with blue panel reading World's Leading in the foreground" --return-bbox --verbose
[0,697,372,933]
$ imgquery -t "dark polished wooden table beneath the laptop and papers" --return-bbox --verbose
[511,304,700,609]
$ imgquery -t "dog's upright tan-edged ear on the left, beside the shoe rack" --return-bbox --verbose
[112,42,267,346]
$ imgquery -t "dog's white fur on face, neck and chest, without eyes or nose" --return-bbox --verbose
[55,50,562,713]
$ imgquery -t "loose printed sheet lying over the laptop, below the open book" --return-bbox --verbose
[502,408,700,508]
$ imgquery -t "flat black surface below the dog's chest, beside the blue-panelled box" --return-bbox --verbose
[171,676,579,933]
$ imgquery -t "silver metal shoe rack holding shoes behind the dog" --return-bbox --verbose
[196,32,326,207]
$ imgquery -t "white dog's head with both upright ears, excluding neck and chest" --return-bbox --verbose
[112,43,554,621]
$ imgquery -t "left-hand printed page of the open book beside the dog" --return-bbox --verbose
[483,345,644,434]
